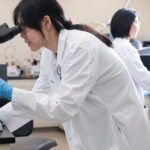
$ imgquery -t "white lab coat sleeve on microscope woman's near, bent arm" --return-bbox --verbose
[9,48,94,122]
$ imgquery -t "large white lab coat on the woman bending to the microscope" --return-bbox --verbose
[0,30,150,150]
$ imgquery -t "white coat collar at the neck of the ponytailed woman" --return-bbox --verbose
[56,29,69,66]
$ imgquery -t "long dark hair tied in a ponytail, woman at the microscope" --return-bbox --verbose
[13,0,113,47]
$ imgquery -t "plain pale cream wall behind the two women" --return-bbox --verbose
[0,0,150,63]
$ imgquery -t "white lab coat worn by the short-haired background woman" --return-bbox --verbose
[113,38,150,104]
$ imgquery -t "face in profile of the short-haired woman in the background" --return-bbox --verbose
[129,17,140,40]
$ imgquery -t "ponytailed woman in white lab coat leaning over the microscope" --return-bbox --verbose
[0,0,150,150]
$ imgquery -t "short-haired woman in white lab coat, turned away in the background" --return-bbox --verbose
[110,8,150,105]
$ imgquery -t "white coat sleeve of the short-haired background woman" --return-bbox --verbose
[117,45,150,91]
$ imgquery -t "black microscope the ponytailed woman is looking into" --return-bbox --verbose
[0,23,22,132]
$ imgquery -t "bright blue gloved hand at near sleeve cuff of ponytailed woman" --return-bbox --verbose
[0,78,13,101]
